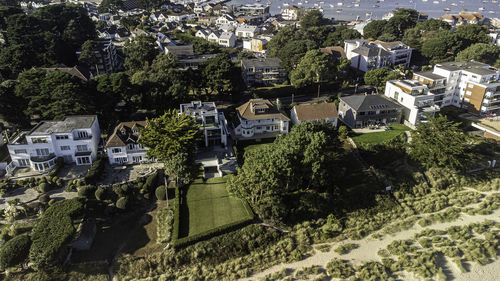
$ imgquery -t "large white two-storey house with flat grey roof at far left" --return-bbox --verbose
[7,115,101,173]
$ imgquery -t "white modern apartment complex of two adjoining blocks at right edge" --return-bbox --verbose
[385,61,500,125]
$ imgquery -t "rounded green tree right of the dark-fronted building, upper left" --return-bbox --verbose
[123,35,158,73]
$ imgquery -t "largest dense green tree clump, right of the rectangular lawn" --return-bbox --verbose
[227,122,341,221]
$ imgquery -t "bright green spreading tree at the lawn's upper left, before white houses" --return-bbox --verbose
[139,110,200,161]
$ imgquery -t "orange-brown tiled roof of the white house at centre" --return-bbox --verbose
[236,99,290,121]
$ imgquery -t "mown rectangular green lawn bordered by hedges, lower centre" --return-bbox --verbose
[180,178,252,236]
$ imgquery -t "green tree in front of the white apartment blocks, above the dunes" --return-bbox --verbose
[410,116,470,170]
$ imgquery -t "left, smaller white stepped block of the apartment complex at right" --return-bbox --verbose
[385,79,440,127]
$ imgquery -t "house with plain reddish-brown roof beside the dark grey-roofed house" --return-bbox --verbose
[290,102,339,127]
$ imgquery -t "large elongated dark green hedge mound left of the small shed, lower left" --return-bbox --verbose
[29,198,83,269]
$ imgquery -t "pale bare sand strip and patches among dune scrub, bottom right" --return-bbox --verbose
[240,190,500,281]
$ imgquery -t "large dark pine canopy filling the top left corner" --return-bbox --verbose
[0,4,96,77]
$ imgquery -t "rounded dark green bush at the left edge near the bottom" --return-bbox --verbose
[0,234,31,270]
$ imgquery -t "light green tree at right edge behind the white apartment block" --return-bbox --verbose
[456,43,500,67]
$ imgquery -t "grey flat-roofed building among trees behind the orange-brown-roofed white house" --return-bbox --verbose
[241,58,287,86]
